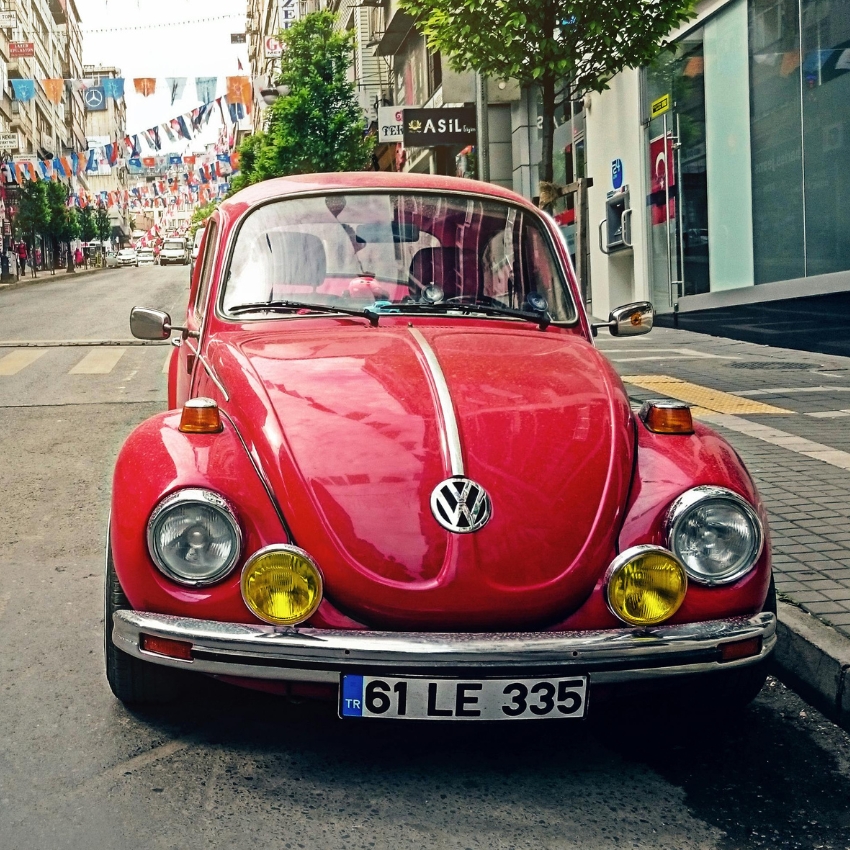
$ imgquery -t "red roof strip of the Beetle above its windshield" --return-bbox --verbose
[220,171,532,217]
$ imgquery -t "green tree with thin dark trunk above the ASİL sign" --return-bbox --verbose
[399,0,694,190]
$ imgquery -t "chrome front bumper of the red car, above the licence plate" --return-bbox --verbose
[112,611,776,683]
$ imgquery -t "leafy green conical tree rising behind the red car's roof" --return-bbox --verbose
[232,12,373,191]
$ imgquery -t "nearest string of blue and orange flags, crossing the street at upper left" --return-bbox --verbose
[9,75,253,114]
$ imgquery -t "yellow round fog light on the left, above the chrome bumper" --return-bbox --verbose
[242,546,322,626]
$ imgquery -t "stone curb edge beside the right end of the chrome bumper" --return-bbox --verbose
[773,602,850,730]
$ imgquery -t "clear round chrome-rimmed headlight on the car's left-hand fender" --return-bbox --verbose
[148,488,242,587]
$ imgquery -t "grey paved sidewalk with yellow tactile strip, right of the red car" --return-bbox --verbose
[597,328,850,637]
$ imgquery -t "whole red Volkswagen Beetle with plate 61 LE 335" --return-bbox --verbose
[104,173,776,721]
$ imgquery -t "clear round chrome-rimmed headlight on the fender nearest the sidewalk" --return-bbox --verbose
[665,487,764,585]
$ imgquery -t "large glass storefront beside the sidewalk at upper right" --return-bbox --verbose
[644,0,850,310]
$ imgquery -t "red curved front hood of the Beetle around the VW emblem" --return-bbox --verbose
[209,320,634,630]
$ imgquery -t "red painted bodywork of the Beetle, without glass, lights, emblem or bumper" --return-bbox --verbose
[111,173,770,644]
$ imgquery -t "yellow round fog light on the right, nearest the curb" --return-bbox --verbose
[606,546,688,626]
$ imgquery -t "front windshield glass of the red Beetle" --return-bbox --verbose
[222,194,576,322]
